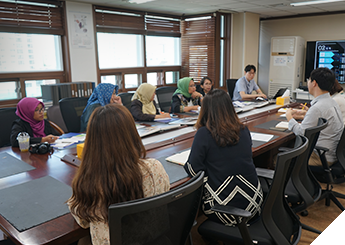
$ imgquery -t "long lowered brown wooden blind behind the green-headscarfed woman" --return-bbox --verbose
[181,17,216,82]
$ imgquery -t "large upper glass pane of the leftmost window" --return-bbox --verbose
[0,32,63,73]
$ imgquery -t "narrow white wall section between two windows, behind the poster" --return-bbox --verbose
[66,1,97,84]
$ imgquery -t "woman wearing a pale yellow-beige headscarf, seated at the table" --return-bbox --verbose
[131,83,170,121]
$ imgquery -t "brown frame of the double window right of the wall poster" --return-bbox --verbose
[94,5,181,93]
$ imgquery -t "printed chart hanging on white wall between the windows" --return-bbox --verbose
[70,12,92,48]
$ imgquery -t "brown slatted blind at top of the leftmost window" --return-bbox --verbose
[0,0,64,35]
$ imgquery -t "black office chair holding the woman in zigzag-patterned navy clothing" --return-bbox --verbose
[198,136,308,245]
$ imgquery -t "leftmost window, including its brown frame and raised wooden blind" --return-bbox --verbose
[0,0,69,107]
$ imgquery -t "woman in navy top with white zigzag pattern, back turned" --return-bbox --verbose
[184,89,263,225]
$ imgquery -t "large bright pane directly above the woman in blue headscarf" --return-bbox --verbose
[97,32,144,69]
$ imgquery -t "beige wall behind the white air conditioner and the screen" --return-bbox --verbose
[258,14,345,93]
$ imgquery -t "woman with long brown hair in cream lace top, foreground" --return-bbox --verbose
[68,104,170,245]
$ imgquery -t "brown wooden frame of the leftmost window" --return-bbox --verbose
[0,0,71,108]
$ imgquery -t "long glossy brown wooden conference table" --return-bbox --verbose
[0,101,295,245]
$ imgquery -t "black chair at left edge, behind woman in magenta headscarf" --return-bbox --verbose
[0,107,19,147]
